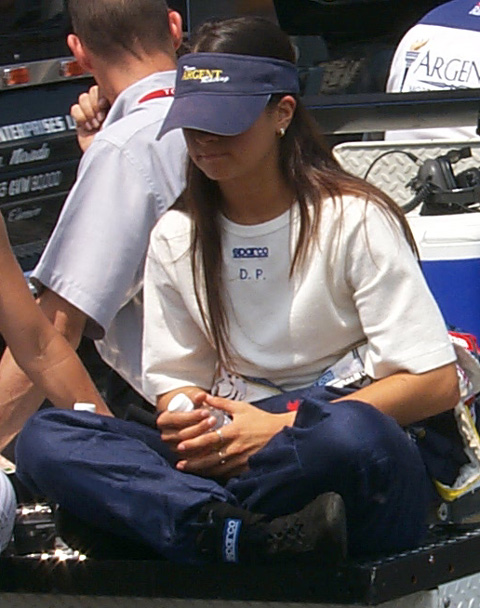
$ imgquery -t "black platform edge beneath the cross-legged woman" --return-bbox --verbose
[0,527,480,608]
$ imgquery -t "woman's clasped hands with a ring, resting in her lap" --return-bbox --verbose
[157,391,295,478]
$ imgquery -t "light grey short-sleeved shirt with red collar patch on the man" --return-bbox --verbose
[32,71,186,402]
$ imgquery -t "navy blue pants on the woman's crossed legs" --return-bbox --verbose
[16,398,430,563]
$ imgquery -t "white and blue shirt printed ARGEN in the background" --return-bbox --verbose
[385,0,480,141]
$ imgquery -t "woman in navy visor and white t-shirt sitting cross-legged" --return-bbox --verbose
[13,18,459,562]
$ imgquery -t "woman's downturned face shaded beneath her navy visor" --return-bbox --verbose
[184,98,295,183]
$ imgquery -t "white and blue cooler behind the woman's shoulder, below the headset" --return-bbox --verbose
[408,213,480,338]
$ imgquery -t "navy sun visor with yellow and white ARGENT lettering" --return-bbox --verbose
[158,53,300,138]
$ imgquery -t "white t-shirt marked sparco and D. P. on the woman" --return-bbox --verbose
[143,197,455,400]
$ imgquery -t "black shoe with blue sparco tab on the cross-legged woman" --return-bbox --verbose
[197,492,347,564]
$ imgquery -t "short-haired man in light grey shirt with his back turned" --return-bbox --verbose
[0,0,185,448]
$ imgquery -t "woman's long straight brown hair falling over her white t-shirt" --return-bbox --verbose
[183,17,416,367]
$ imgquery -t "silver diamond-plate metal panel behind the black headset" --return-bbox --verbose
[333,140,480,205]
